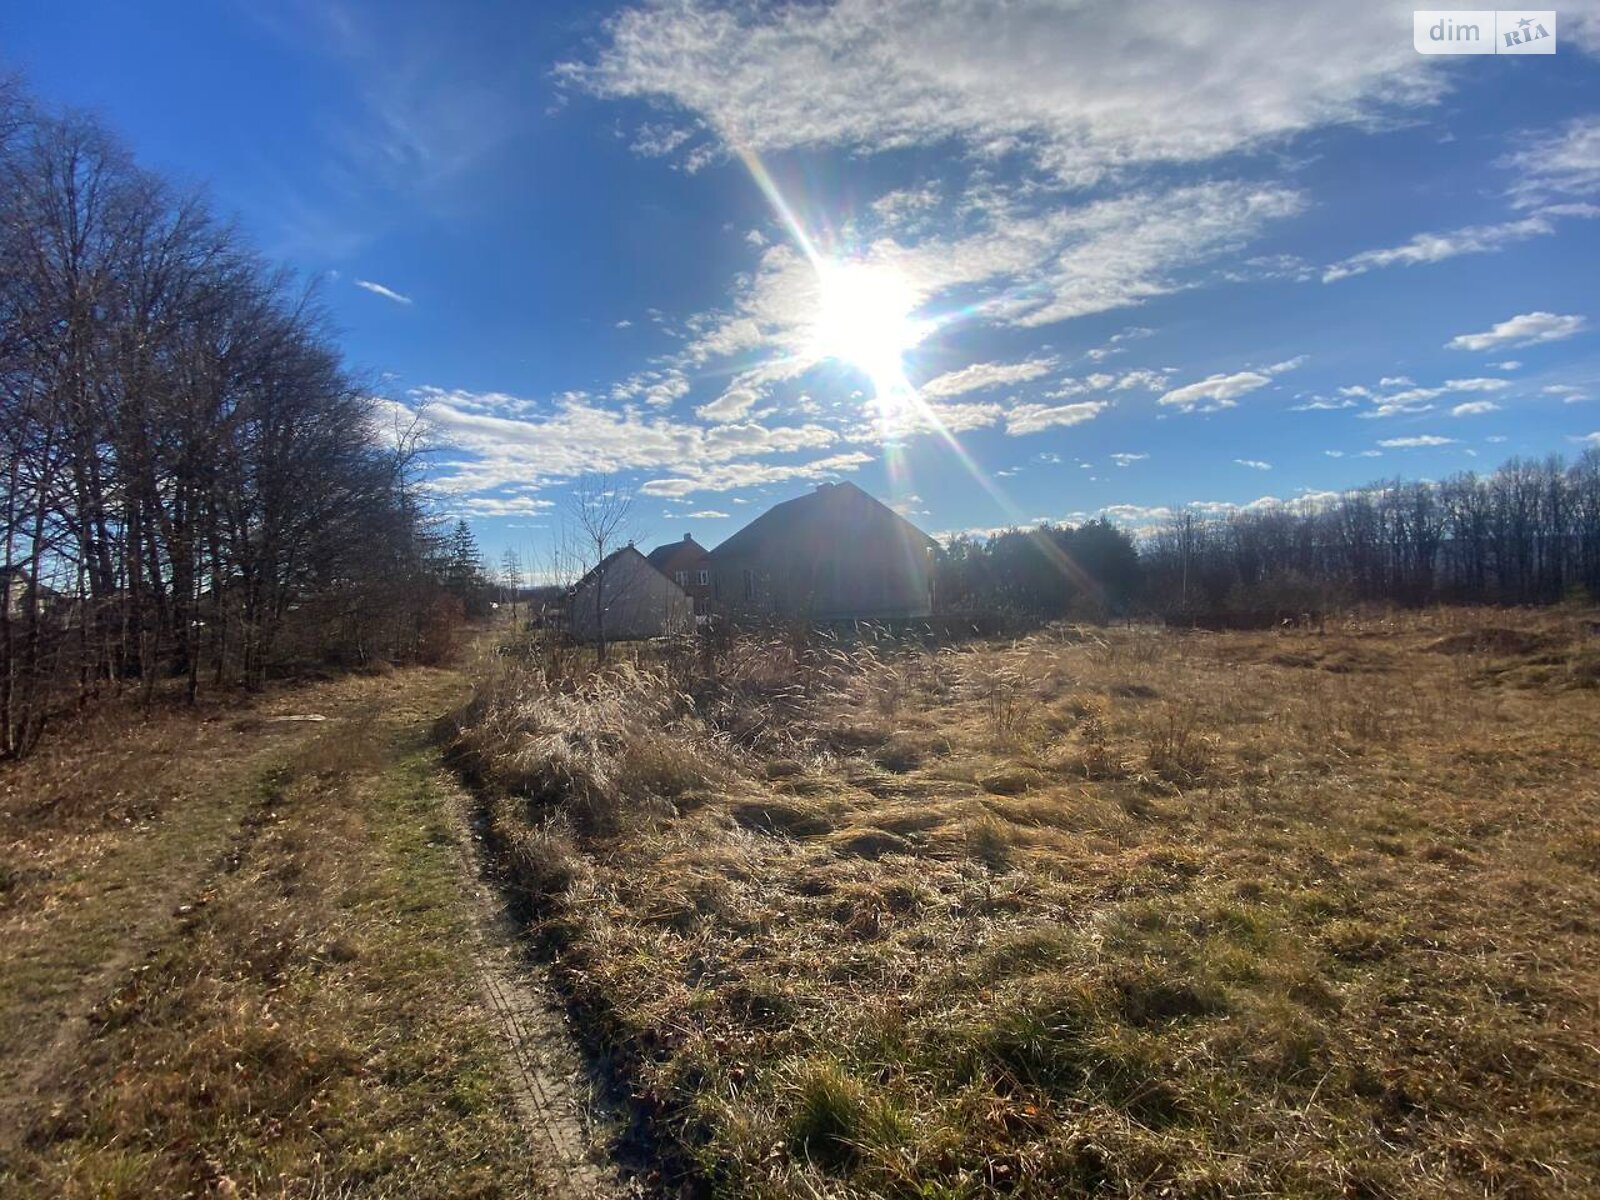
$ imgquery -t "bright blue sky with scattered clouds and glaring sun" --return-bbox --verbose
[9,0,1600,560]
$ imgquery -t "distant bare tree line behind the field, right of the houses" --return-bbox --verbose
[934,448,1600,619]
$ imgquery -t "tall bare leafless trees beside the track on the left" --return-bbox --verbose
[0,82,483,755]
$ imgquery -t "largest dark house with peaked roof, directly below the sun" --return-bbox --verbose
[709,483,938,621]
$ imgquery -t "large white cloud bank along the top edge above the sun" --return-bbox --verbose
[558,0,1445,184]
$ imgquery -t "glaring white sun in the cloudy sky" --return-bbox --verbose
[811,262,926,405]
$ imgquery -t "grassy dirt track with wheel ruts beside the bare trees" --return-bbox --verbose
[0,670,640,1200]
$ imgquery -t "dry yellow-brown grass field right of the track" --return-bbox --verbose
[456,610,1600,1197]
